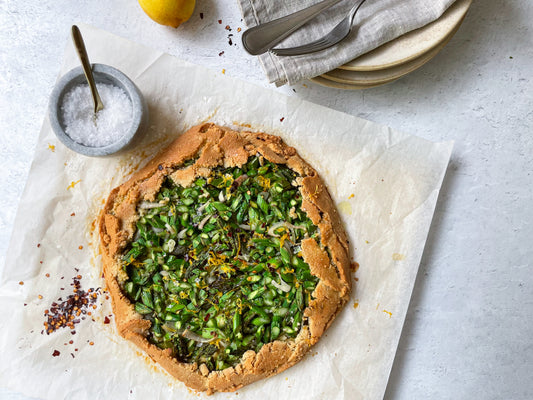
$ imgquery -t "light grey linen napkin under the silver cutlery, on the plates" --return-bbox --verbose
[238,0,455,86]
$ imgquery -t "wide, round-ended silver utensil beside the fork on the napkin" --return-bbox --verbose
[242,0,341,56]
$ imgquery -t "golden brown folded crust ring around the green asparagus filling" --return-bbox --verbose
[99,123,351,394]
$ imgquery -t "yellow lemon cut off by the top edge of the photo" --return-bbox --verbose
[139,0,196,28]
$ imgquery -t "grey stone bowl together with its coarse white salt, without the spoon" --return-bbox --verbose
[49,64,148,156]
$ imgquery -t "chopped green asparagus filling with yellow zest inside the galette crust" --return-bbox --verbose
[122,157,318,370]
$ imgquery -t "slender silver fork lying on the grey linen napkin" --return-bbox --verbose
[270,0,366,56]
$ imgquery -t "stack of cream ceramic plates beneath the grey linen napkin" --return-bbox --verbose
[311,0,472,89]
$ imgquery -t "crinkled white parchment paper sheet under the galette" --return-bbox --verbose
[0,26,452,400]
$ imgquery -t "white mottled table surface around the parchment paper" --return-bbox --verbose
[0,0,533,400]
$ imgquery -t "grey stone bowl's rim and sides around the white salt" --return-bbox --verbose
[48,64,148,157]
